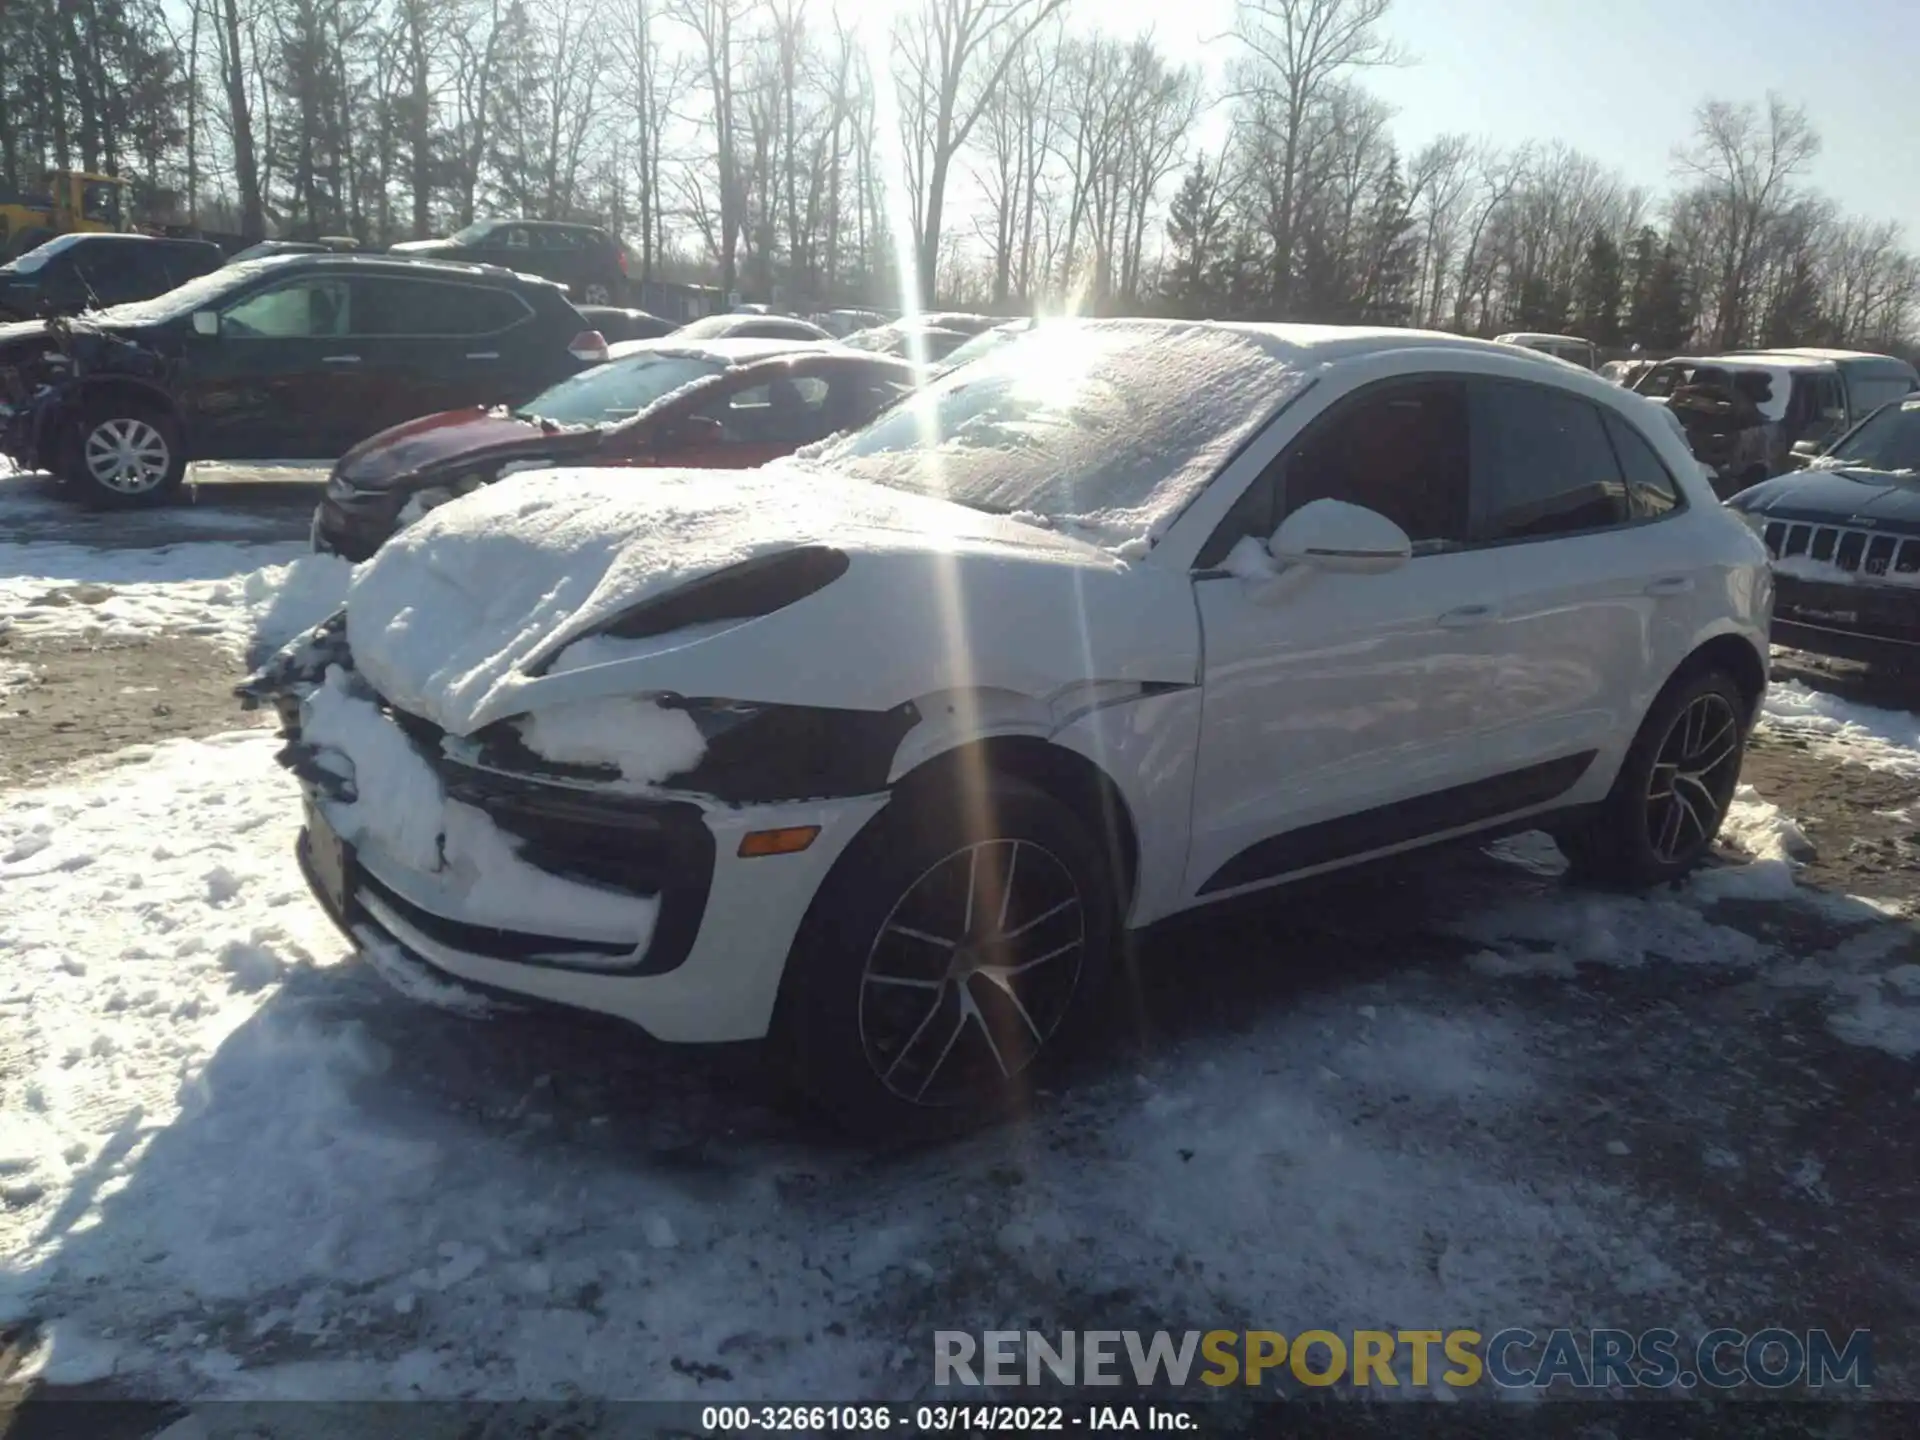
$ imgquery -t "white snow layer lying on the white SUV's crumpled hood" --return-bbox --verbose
[348,463,1110,733]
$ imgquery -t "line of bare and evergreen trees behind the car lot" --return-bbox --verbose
[0,0,1920,351]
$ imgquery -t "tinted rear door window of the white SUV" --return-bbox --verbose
[1473,380,1632,543]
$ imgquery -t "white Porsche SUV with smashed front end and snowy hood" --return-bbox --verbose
[242,321,1772,1131]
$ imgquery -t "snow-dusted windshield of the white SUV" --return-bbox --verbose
[818,321,1306,545]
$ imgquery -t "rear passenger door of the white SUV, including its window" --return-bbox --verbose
[1443,376,1695,799]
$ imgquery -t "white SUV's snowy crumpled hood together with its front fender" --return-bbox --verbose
[337,461,1198,735]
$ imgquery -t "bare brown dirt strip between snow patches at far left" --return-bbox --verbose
[0,634,266,785]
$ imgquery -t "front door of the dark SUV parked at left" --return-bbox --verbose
[179,271,372,461]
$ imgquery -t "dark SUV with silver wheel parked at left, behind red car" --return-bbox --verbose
[0,255,607,505]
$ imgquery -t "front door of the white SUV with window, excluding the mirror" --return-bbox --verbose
[1187,374,1524,897]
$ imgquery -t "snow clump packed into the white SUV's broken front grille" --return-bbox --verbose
[301,666,660,948]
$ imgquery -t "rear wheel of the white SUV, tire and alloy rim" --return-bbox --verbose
[1559,670,1749,889]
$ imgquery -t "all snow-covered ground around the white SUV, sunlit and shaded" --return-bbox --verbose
[0,492,1920,1400]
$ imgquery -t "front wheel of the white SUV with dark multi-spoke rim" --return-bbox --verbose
[776,776,1119,1139]
